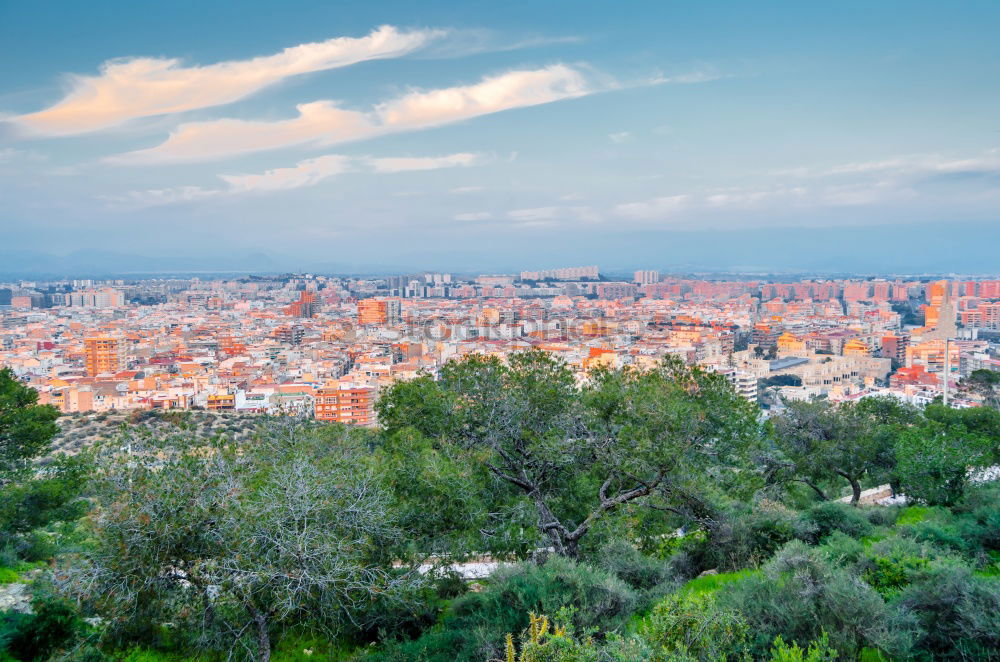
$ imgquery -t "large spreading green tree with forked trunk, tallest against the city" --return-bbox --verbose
[380,351,758,557]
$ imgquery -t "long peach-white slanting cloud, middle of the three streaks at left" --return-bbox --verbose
[108,65,593,163]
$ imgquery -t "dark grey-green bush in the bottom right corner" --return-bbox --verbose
[898,564,1000,660]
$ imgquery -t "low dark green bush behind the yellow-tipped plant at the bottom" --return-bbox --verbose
[374,556,638,662]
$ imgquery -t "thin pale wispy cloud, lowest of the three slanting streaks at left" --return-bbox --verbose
[102,152,484,207]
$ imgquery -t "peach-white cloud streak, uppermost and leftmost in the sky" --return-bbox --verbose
[13,26,443,135]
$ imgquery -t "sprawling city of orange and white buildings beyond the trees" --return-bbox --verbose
[0,267,1000,425]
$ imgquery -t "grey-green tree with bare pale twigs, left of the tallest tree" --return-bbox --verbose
[65,426,413,660]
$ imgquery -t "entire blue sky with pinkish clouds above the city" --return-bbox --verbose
[0,0,1000,273]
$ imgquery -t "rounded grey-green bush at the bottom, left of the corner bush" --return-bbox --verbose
[719,541,914,658]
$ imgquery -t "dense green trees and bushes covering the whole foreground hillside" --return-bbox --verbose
[0,352,1000,662]
